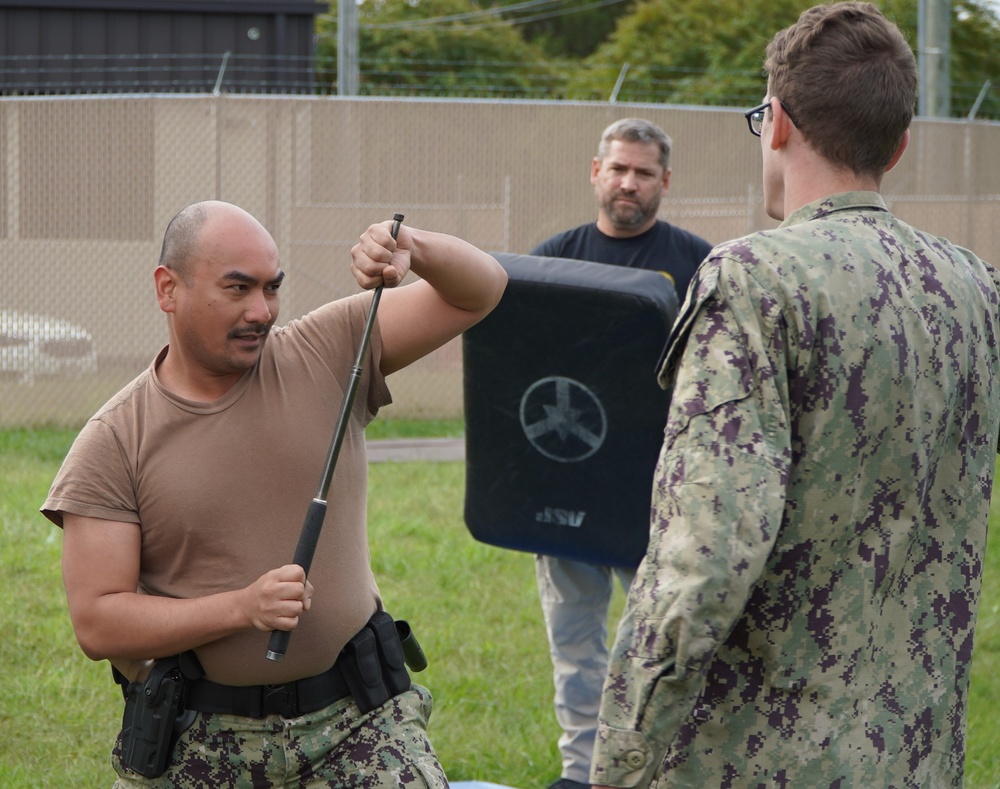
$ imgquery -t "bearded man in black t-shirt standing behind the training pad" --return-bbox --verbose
[531,118,712,789]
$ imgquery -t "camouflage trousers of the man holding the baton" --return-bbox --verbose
[111,685,448,789]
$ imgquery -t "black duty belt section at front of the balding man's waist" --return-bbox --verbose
[186,665,351,718]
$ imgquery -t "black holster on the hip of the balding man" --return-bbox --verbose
[112,653,201,778]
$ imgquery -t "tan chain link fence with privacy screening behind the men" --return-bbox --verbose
[0,94,1000,427]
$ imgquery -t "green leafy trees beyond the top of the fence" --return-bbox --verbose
[317,0,1000,118]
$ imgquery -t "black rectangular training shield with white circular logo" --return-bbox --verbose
[463,253,678,567]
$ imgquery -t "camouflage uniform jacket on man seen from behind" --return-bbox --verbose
[591,192,1000,789]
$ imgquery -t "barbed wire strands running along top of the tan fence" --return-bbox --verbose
[0,52,1000,120]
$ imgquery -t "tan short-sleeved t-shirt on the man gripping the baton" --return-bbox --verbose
[42,294,391,685]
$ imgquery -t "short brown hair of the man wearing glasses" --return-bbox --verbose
[764,2,917,177]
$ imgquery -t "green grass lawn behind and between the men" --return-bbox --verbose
[0,428,1000,789]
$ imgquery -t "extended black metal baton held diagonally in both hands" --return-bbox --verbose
[267,214,403,662]
